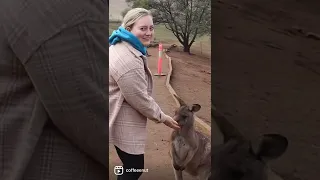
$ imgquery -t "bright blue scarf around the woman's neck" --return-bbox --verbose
[109,26,147,55]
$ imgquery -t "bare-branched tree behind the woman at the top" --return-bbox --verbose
[149,0,211,53]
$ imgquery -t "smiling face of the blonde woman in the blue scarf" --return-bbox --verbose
[130,15,154,46]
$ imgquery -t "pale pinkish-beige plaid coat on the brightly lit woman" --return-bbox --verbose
[109,42,165,154]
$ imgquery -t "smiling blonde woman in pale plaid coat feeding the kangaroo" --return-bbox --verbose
[109,8,180,180]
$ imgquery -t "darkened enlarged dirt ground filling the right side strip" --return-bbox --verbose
[212,0,320,180]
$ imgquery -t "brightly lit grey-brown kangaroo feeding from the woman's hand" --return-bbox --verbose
[169,95,211,180]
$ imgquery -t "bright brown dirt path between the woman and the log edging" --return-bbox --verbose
[109,48,192,180]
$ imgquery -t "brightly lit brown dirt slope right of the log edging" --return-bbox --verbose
[168,51,211,125]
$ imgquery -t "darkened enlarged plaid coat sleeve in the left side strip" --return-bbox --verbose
[24,21,108,166]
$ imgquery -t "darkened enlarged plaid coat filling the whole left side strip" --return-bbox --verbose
[0,0,108,180]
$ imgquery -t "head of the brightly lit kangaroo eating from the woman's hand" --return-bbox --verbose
[173,95,201,126]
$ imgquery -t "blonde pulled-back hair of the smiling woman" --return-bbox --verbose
[121,8,152,28]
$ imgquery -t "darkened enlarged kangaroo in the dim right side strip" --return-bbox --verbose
[210,106,288,180]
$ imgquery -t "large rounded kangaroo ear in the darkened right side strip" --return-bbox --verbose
[251,134,289,160]
